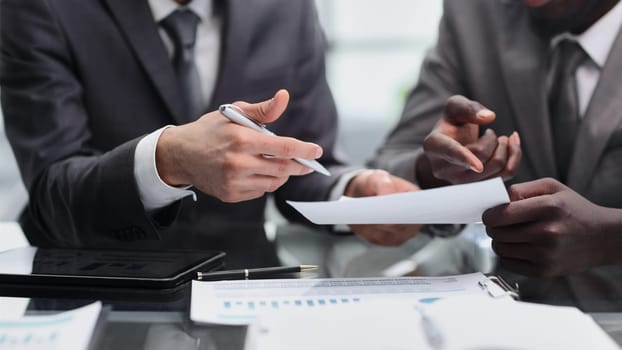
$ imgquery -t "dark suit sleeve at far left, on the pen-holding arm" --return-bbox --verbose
[0,0,157,246]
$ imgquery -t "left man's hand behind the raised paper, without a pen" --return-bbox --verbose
[344,170,422,246]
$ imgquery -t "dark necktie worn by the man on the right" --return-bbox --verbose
[548,40,589,183]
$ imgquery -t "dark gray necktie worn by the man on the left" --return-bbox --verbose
[161,9,205,119]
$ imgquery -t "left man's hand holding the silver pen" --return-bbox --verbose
[156,90,322,202]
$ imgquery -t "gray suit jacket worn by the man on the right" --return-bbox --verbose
[373,0,622,311]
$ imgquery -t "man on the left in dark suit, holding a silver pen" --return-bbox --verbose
[0,0,418,267]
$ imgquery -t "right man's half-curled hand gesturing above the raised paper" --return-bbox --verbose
[417,96,522,187]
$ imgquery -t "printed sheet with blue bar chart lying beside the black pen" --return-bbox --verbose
[190,273,504,325]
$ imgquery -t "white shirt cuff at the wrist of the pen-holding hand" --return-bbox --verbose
[134,125,197,212]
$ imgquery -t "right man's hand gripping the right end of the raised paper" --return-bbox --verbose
[482,178,622,277]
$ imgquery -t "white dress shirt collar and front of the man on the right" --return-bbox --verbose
[553,2,622,117]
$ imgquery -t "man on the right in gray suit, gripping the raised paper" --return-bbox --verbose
[374,0,622,311]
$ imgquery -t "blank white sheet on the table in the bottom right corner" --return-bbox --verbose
[426,297,619,350]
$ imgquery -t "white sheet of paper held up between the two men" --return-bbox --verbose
[287,178,510,225]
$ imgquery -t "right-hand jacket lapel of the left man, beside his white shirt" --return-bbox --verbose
[207,0,255,110]
